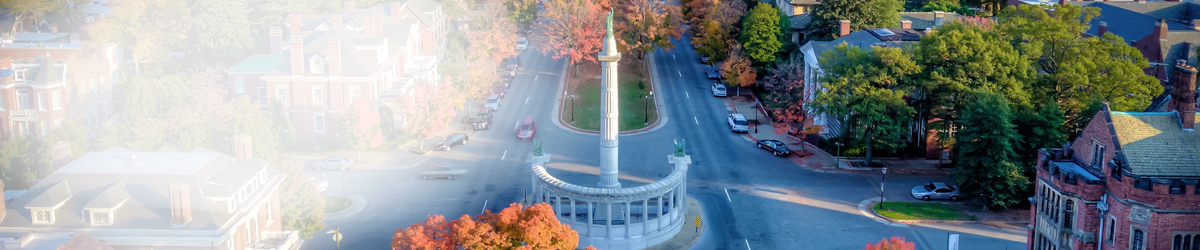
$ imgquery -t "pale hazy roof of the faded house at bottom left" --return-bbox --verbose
[0,148,281,230]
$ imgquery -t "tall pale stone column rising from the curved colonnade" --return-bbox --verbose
[598,11,620,189]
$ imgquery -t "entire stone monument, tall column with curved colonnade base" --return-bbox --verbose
[528,12,691,250]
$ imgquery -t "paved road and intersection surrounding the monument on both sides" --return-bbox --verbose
[305,33,1025,249]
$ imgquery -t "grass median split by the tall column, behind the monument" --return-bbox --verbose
[562,69,658,131]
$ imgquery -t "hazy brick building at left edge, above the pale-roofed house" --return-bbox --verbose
[0,32,120,142]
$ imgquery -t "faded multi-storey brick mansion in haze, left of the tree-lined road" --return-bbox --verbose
[226,0,449,143]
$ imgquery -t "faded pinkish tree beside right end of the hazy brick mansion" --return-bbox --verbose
[401,82,454,150]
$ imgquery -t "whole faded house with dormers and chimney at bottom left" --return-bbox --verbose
[0,136,302,250]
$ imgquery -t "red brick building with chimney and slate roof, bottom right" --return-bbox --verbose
[1027,60,1200,250]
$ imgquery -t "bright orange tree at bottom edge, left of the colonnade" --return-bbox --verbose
[391,203,595,250]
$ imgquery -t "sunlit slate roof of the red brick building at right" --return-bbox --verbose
[1110,112,1200,177]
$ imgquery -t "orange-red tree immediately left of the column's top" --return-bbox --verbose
[538,0,607,75]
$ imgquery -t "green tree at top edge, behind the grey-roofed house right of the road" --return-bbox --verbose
[804,0,904,41]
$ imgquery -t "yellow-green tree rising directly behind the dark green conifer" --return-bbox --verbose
[912,22,1034,145]
